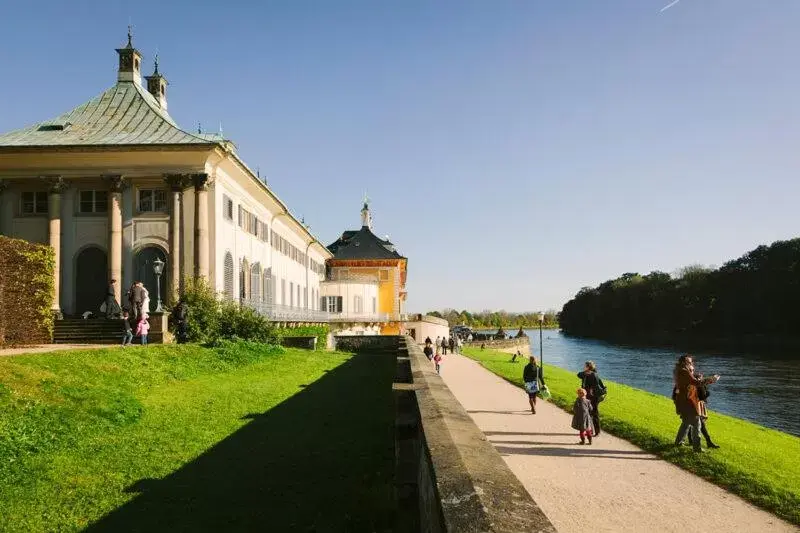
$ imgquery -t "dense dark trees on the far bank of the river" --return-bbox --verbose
[559,238,800,338]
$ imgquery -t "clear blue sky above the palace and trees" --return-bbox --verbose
[0,0,800,311]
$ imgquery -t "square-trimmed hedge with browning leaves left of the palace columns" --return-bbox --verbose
[0,236,56,346]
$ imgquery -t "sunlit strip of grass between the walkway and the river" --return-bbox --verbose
[464,348,800,525]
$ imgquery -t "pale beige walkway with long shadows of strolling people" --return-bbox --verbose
[442,355,800,533]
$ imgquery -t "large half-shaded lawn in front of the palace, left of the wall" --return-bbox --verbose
[0,343,395,532]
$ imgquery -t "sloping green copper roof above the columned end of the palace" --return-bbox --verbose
[0,81,225,147]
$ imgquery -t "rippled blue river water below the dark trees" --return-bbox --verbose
[490,330,800,437]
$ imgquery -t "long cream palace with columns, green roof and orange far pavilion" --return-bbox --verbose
[0,33,328,321]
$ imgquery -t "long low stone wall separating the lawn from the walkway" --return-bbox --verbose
[394,337,555,533]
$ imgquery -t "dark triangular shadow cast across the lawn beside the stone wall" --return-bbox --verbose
[86,355,396,533]
